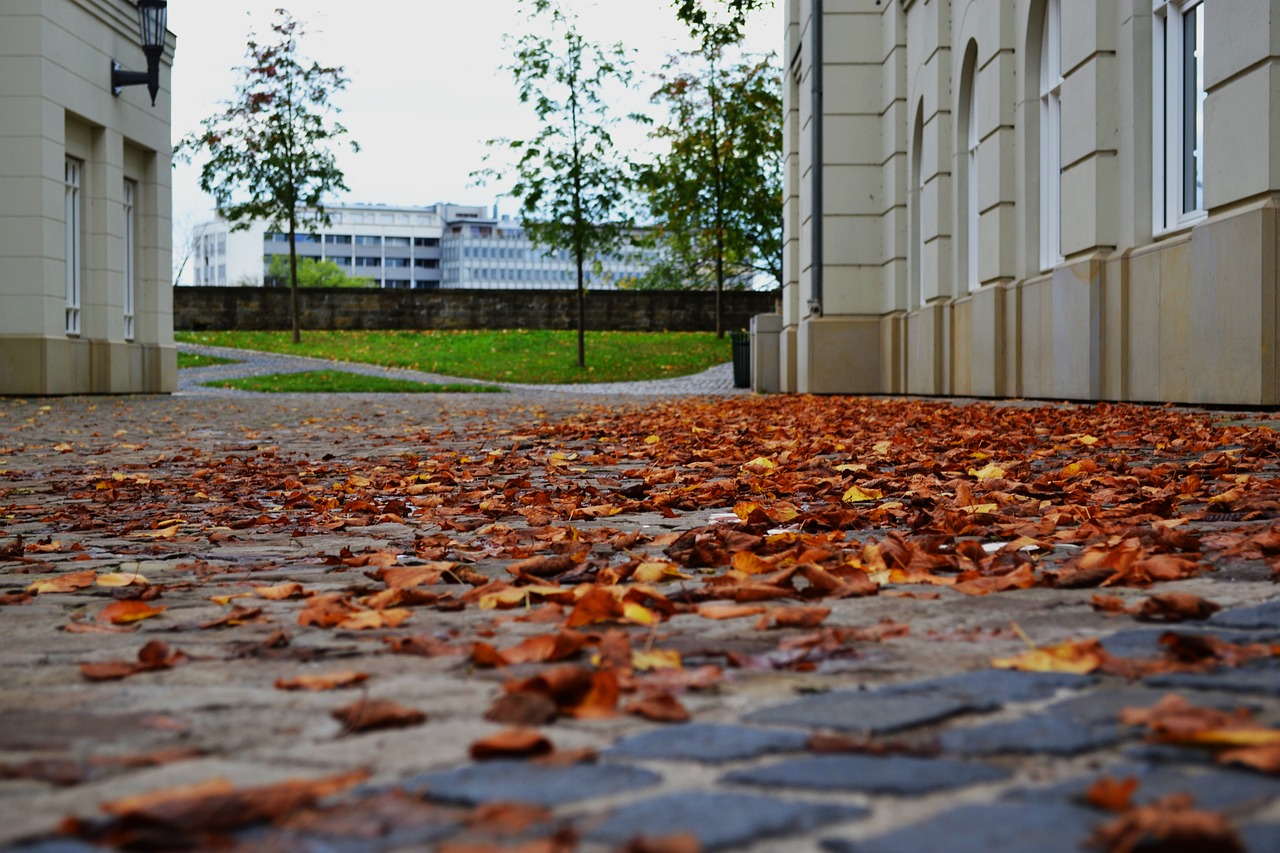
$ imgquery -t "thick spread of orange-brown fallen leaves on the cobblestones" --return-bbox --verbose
[7,397,1280,849]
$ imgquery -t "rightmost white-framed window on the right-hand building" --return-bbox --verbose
[1151,0,1204,232]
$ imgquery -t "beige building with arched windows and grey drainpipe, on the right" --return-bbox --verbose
[773,0,1280,406]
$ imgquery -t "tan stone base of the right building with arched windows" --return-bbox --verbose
[781,196,1280,406]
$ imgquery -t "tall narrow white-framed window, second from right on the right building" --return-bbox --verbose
[1039,0,1062,270]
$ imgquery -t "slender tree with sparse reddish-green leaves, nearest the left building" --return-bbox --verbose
[175,9,360,343]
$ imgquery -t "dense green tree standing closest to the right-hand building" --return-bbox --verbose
[640,43,782,336]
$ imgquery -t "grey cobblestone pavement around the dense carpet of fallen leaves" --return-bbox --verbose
[0,379,1280,853]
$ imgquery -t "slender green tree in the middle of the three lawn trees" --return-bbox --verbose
[476,0,631,368]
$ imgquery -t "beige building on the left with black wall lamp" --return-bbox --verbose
[0,0,177,394]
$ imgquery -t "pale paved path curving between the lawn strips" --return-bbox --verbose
[178,343,750,397]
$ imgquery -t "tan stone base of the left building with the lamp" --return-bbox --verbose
[0,336,178,397]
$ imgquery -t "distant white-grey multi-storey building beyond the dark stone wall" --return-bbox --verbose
[191,204,648,289]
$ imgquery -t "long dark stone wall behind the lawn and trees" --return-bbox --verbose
[173,287,777,332]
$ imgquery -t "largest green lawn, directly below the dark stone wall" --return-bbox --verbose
[174,329,732,384]
